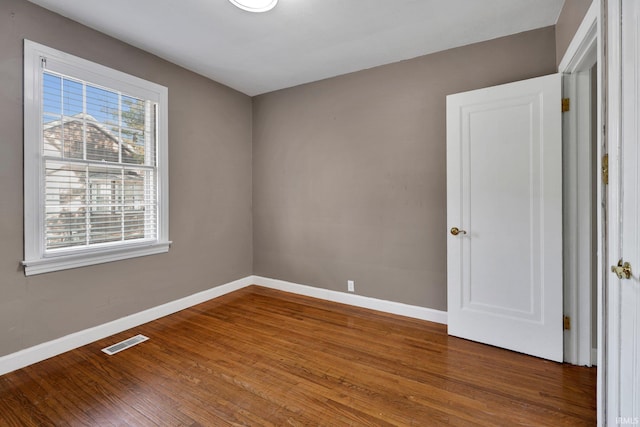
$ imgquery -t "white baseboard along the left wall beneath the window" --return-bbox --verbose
[0,276,252,375]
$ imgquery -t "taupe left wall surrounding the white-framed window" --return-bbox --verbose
[0,0,252,355]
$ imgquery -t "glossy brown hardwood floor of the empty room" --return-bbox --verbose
[0,286,596,426]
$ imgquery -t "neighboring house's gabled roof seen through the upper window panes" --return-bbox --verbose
[43,113,140,164]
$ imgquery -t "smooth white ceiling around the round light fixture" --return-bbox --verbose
[30,0,564,96]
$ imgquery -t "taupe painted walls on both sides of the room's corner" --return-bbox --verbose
[0,0,556,356]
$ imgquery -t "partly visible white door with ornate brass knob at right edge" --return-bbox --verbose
[606,0,640,425]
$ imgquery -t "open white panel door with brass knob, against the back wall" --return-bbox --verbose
[447,74,563,362]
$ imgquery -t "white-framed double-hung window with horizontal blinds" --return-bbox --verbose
[23,40,171,275]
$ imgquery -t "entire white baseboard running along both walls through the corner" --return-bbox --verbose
[0,276,447,375]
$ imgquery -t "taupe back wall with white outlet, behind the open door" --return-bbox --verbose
[253,27,556,310]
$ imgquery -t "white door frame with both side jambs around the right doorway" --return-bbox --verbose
[558,0,607,425]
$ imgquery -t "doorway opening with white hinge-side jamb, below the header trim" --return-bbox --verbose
[563,62,601,366]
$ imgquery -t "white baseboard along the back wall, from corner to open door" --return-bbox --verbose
[252,276,447,325]
